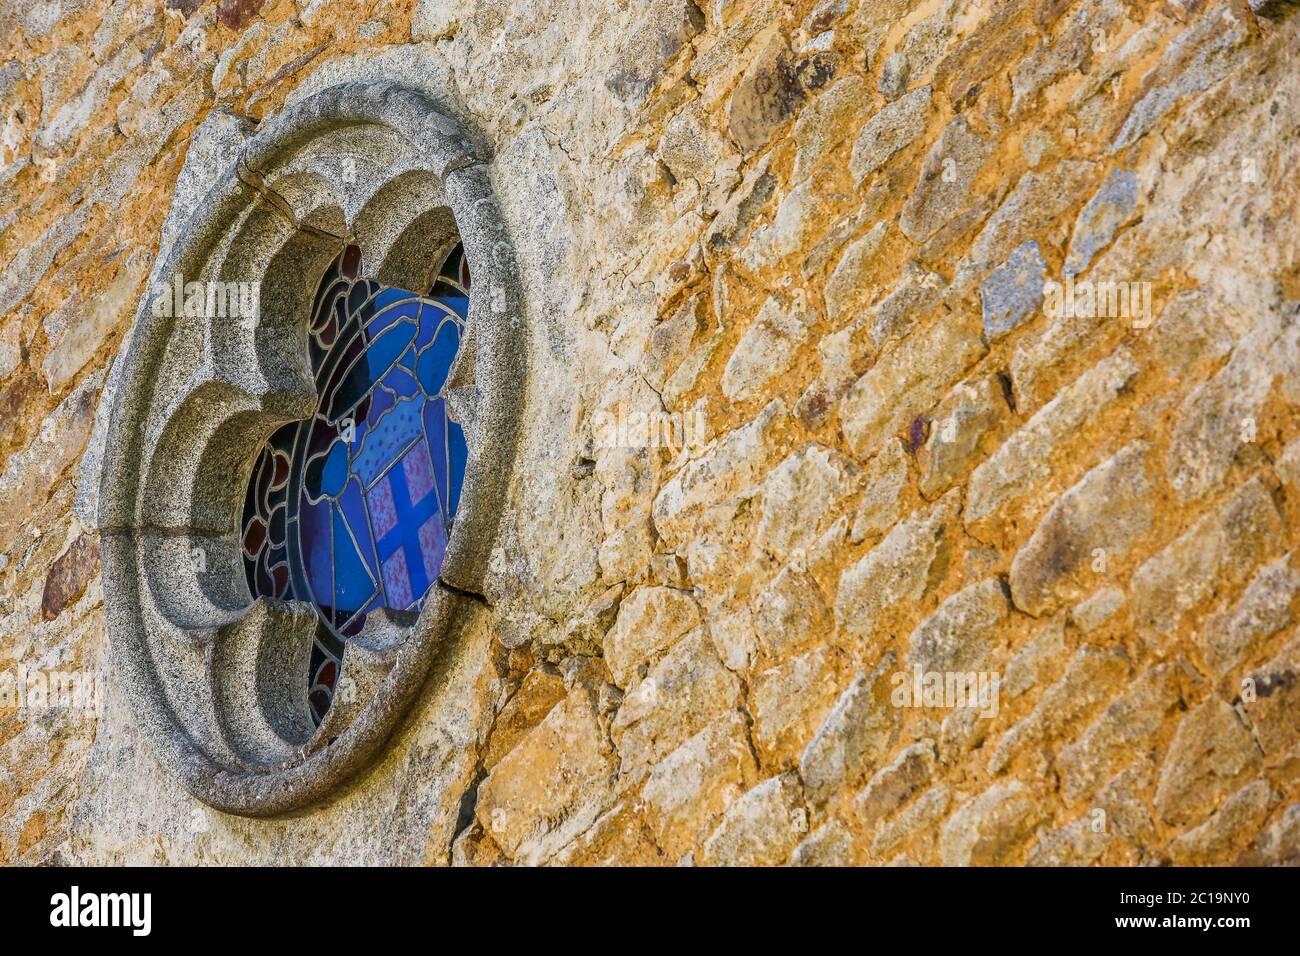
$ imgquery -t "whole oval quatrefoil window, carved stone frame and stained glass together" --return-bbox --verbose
[81,83,527,816]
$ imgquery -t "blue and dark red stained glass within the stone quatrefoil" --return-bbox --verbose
[241,246,469,723]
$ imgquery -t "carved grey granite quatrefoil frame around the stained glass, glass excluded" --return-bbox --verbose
[78,83,527,817]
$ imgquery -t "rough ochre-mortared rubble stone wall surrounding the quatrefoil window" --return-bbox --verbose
[0,0,1300,865]
